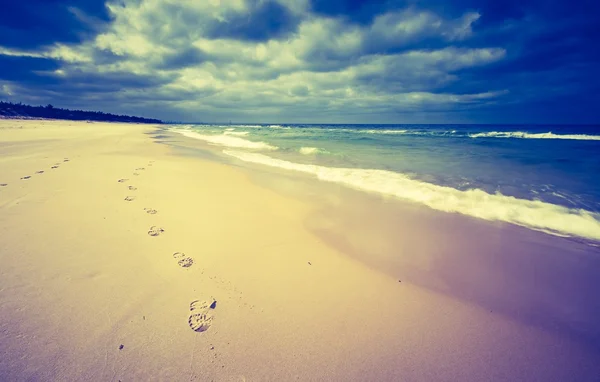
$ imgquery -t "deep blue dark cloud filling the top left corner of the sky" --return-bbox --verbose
[0,0,109,48]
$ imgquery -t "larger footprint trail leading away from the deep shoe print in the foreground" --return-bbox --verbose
[117,161,211,333]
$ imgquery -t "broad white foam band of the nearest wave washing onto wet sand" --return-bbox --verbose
[224,150,600,240]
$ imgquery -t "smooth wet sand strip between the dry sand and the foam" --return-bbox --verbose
[166,129,600,350]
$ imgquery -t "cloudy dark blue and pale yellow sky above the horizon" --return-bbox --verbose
[0,0,600,124]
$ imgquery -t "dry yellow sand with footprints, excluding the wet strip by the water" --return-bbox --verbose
[0,120,600,382]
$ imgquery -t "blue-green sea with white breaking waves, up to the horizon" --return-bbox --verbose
[169,124,600,247]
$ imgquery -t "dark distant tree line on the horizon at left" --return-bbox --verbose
[0,101,163,123]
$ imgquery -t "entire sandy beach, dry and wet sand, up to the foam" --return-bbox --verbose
[0,120,600,382]
